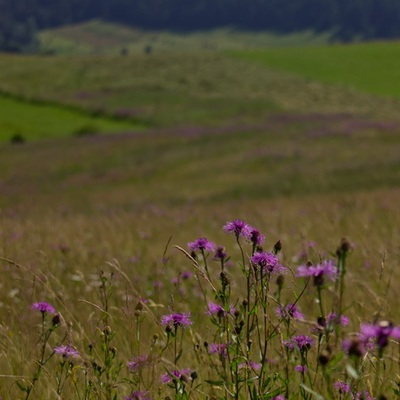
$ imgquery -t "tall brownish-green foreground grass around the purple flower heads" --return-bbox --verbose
[0,191,399,399]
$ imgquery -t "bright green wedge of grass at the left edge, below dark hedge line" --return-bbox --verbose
[0,96,140,142]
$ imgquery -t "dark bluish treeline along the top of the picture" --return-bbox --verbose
[0,0,400,51]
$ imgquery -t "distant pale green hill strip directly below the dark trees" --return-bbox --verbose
[39,20,329,54]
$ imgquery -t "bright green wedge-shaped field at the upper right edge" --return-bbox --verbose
[232,41,400,98]
